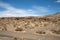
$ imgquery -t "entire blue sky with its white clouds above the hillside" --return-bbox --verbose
[0,0,60,17]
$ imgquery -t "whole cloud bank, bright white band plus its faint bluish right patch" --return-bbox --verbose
[0,2,49,17]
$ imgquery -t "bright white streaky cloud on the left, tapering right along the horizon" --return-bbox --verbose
[0,2,37,17]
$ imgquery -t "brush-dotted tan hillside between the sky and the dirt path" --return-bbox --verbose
[0,13,60,35]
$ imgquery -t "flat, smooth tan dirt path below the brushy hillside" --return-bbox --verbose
[0,32,60,40]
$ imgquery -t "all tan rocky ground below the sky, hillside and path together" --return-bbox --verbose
[0,13,60,40]
